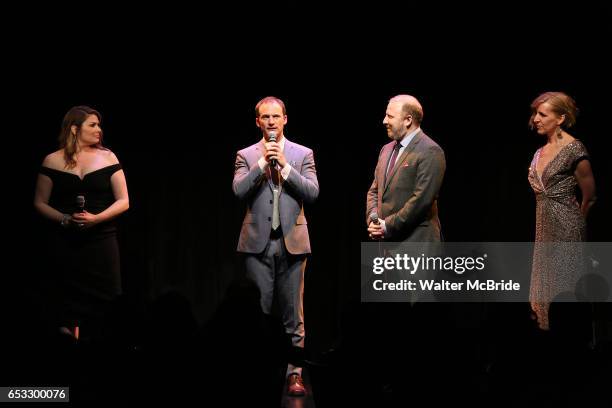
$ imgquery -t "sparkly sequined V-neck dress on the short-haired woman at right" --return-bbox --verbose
[528,139,588,330]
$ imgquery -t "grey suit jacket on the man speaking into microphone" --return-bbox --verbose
[232,139,319,255]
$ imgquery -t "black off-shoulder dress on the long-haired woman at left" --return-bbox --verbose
[40,164,121,331]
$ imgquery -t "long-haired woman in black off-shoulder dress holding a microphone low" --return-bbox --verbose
[34,106,129,339]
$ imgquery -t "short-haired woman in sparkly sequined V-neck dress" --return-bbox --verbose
[529,92,595,330]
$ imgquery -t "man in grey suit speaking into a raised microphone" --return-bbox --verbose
[233,97,319,396]
